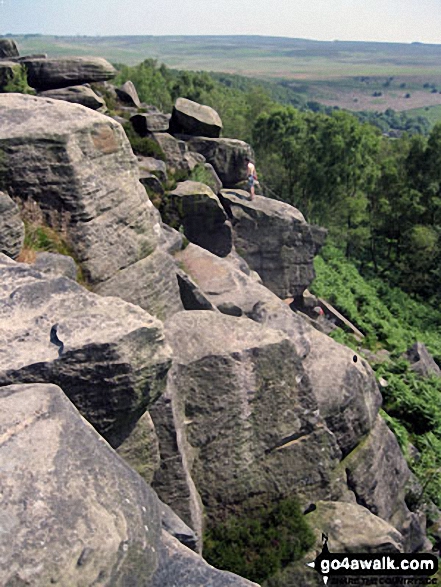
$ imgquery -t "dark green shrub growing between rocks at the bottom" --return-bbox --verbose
[204,499,315,583]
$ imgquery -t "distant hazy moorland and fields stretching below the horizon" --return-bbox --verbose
[14,35,441,115]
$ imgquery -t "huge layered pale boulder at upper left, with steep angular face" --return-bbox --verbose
[0,94,182,320]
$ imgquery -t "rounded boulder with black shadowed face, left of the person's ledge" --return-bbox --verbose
[161,181,233,257]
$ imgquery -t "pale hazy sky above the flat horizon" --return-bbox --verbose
[0,0,441,44]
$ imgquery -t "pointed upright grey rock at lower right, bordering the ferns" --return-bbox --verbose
[342,416,425,552]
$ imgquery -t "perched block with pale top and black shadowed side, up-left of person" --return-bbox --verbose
[170,98,222,138]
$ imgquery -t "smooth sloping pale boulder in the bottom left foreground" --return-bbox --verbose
[0,383,256,587]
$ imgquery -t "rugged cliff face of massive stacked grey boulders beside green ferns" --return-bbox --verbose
[0,47,432,587]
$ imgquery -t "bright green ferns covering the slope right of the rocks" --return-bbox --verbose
[312,247,441,507]
